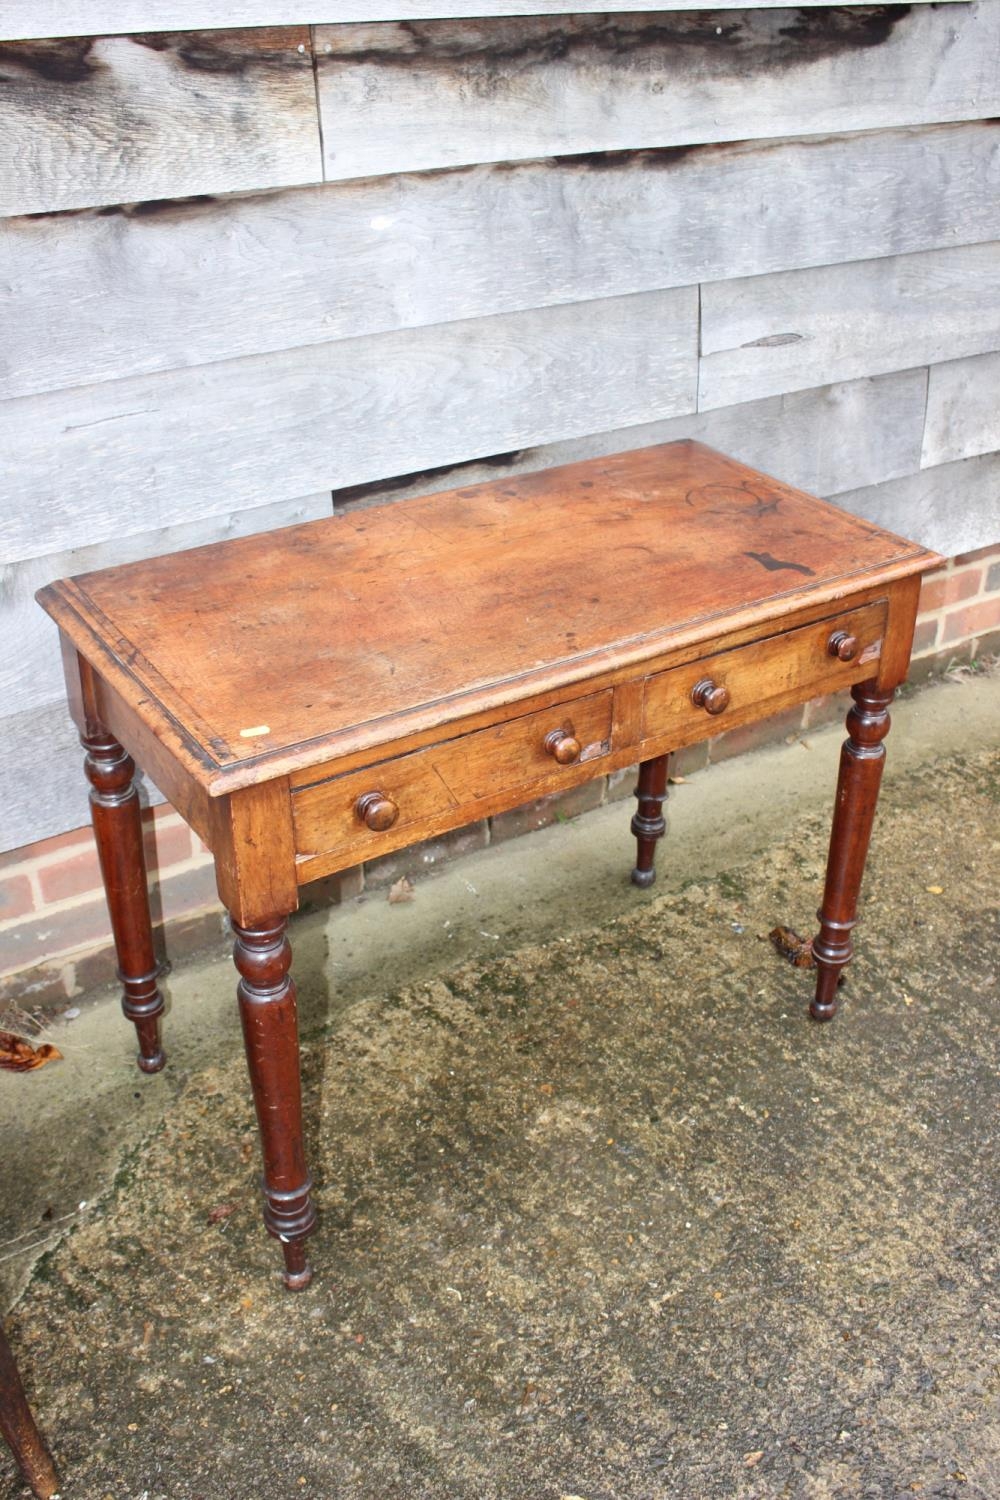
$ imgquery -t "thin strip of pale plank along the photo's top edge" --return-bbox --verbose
[0,0,958,41]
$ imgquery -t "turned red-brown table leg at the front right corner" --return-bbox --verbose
[810,681,894,1022]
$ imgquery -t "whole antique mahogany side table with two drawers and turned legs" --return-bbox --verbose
[37,443,940,1289]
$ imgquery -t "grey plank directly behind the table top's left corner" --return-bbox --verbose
[0,491,331,714]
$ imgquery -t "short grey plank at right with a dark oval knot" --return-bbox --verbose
[699,243,1000,410]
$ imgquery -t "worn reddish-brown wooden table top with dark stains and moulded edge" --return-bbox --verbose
[37,441,939,794]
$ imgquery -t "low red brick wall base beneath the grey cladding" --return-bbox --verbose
[0,546,1000,1010]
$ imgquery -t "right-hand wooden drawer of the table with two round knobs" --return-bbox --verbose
[643,600,886,749]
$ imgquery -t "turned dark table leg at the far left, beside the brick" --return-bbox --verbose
[81,731,166,1073]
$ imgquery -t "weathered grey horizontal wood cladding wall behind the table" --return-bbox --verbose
[0,0,1000,849]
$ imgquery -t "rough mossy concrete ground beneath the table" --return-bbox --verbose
[0,677,1000,1500]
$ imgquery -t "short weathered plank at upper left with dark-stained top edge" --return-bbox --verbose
[0,27,322,215]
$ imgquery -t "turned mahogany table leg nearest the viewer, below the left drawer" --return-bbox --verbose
[232,917,316,1292]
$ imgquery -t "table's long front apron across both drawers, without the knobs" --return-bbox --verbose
[291,599,888,884]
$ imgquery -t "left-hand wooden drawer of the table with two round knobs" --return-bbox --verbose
[292,689,612,879]
